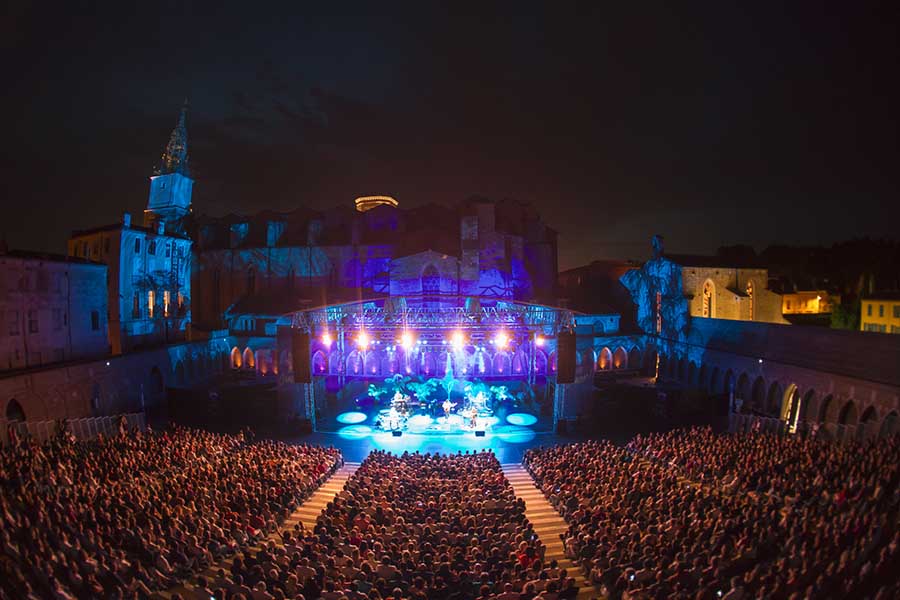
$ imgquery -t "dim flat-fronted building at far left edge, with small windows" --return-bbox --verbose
[0,250,109,371]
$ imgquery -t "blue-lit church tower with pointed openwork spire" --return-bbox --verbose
[144,98,194,233]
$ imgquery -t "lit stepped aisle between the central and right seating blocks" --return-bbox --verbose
[501,464,601,599]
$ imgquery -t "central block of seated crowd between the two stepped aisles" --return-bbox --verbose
[200,451,578,600]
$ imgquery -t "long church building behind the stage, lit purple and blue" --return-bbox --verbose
[193,199,557,335]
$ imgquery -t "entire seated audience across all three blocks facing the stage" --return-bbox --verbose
[0,420,900,600]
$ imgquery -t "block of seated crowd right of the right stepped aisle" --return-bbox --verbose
[524,428,900,600]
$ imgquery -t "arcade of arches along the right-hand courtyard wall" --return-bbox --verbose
[659,356,900,437]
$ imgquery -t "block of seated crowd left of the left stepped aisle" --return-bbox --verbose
[0,428,343,600]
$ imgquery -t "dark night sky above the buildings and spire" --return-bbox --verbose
[0,0,900,268]
